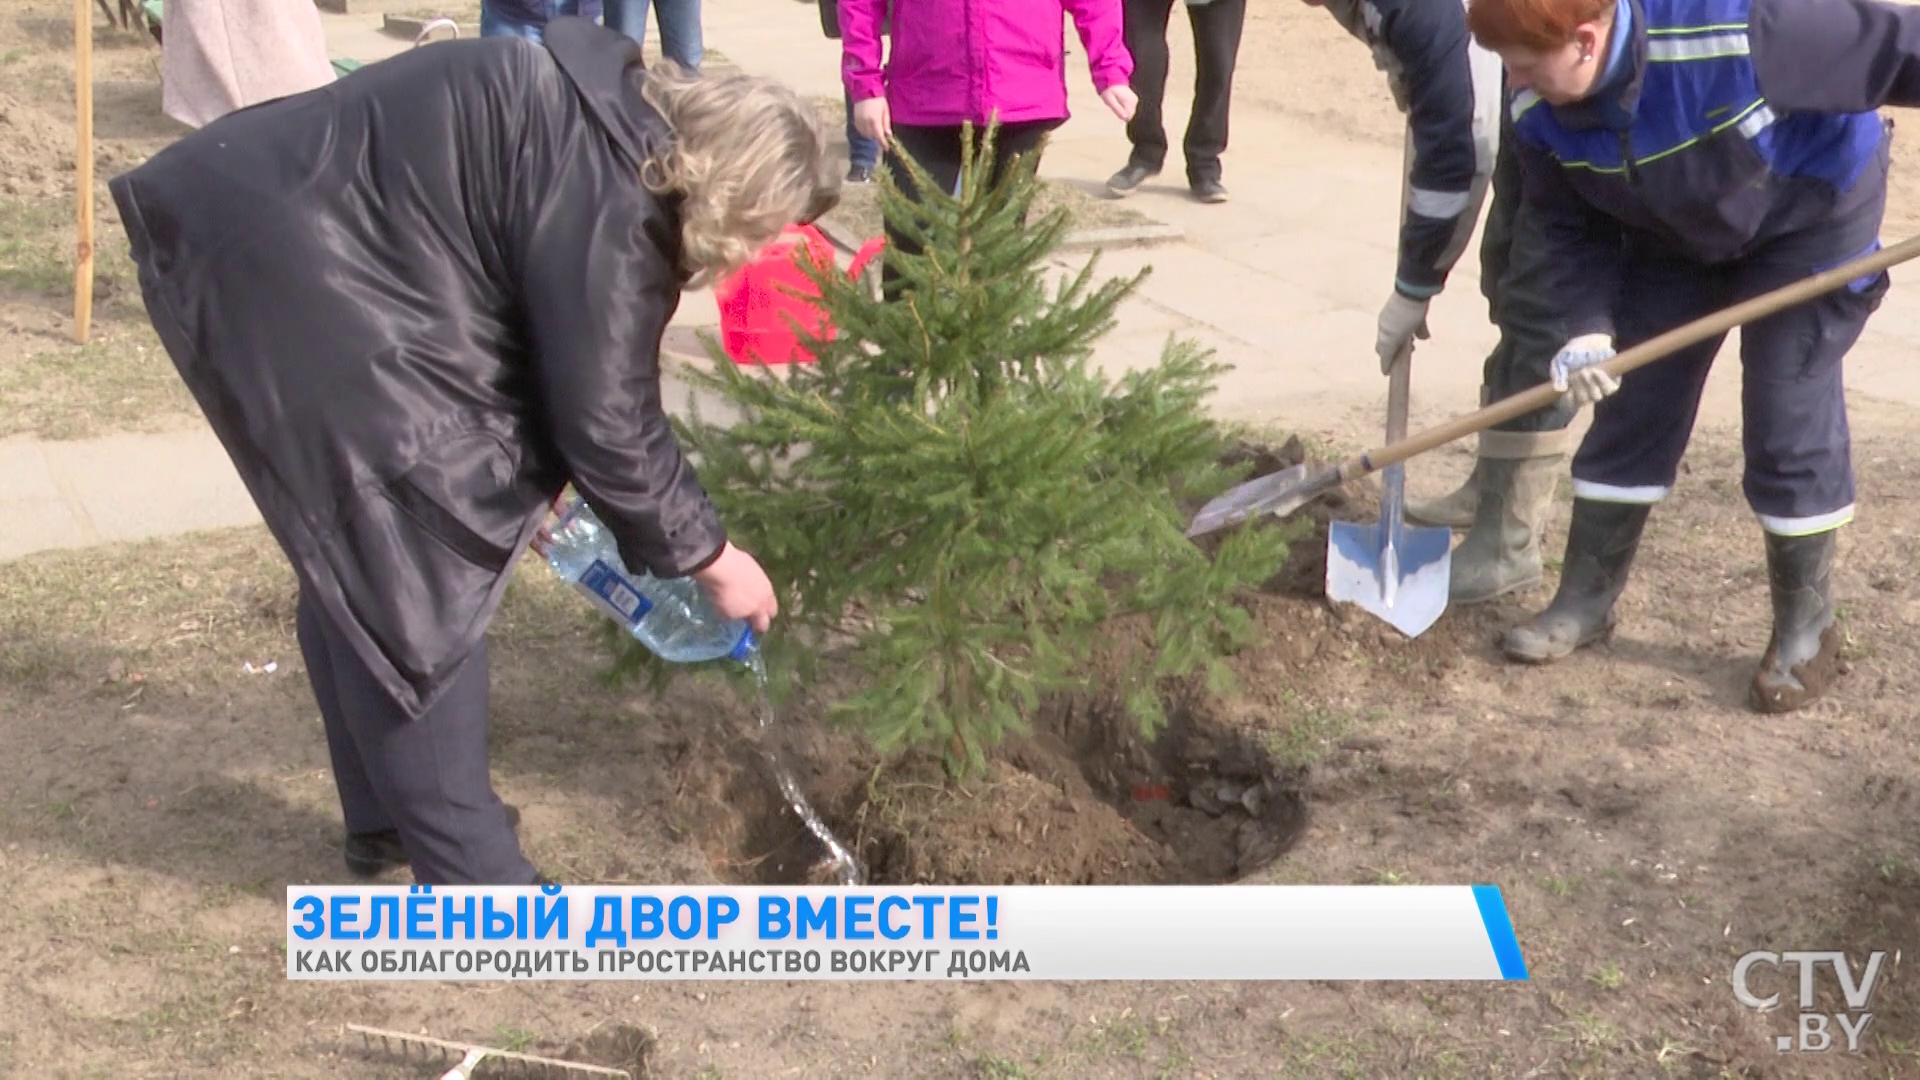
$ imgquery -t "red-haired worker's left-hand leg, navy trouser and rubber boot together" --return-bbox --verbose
[1505,258,1724,663]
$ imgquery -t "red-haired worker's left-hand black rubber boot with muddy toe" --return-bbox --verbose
[1505,498,1653,663]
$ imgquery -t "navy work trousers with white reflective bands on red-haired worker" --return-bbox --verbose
[1572,189,1889,536]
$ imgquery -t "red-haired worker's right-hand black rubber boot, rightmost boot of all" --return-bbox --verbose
[1751,530,1841,713]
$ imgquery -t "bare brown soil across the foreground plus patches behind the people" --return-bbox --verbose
[11,0,1920,1080]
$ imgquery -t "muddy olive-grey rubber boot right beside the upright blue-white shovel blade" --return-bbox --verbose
[1448,430,1569,603]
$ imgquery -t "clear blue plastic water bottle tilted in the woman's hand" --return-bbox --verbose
[534,498,758,663]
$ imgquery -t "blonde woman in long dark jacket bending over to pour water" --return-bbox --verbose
[111,19,835,884]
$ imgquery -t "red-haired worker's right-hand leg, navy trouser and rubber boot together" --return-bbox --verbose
[1740,204,1889,713]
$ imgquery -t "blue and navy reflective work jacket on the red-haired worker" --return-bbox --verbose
[1511,0,1920,334]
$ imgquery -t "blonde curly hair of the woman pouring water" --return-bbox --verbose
[639,60,839,288]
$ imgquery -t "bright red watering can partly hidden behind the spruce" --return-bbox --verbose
[714,225,885,363]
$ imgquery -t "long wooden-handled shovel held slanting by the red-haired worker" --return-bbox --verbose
[1187,236,1920,541]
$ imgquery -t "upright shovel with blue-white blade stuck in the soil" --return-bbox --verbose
[1327,344,1453,638]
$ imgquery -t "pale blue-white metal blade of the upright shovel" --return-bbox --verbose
[1327,519,1453,638]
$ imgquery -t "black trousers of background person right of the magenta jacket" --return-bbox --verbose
[1121,0,1246,184]
